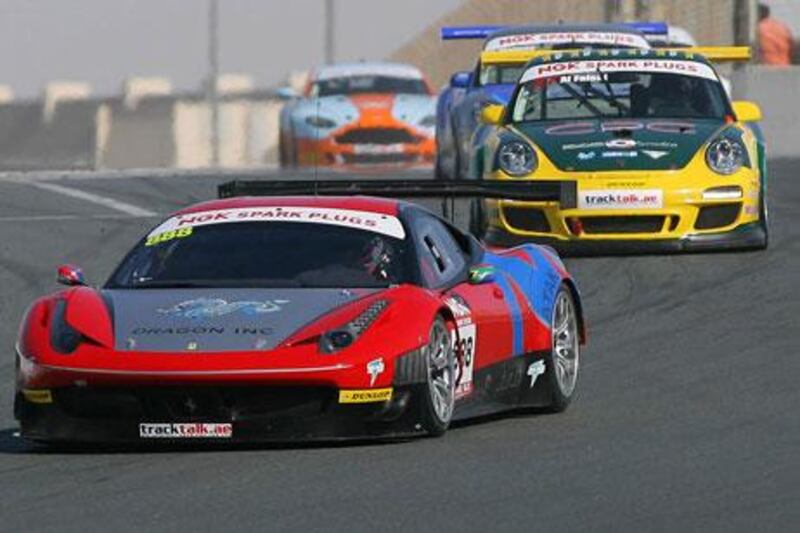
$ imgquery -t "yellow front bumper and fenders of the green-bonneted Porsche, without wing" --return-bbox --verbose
[484,123,761,241]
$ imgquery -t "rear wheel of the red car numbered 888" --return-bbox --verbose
[544,284,580,413]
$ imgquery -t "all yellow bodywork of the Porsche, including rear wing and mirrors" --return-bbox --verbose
[481,47,764,243]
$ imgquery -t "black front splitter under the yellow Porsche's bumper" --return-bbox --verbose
[485,222,767,256]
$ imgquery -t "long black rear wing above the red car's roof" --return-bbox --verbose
[217,179,578,213]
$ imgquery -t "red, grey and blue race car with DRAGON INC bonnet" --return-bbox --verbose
[14,182,585,443]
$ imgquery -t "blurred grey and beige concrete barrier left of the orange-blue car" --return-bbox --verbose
[0,92,283,171]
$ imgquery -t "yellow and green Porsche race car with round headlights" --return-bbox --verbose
[470,48,768,253]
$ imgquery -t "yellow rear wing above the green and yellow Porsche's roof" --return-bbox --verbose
[481,46,752,65]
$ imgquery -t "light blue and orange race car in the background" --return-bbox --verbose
[280,63,436,166]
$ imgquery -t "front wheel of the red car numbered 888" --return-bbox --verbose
[421,317,455,437]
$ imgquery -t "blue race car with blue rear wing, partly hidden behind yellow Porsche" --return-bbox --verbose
[436,23,668,179]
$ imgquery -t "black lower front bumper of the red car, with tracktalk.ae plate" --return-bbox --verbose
[14,384,432,446]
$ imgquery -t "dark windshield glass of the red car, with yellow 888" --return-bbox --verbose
[107,222,413,289]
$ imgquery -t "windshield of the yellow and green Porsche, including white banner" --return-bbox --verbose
[512,61,729,122]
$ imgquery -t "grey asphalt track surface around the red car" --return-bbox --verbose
[0,161,800,531]
